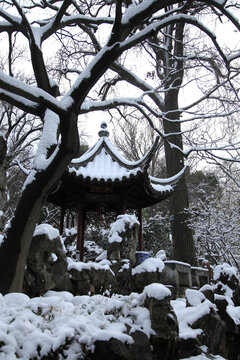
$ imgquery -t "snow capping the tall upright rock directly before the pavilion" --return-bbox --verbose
[108,214,139,244]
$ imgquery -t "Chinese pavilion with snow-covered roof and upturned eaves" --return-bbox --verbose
[47,122,184,261]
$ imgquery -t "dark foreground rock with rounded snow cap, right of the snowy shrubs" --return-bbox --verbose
[86,284,179,360]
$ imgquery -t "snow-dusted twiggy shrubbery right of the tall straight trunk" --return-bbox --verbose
[189,171,240,269]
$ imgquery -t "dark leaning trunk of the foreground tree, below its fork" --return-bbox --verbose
[0,114,79,294]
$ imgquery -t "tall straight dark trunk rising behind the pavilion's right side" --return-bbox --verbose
[152,15,197,265]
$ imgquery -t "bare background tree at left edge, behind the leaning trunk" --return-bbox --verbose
[0,51,42,231]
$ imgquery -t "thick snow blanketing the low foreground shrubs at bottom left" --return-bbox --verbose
[0,291,154,360]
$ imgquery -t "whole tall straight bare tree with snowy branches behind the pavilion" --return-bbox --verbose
[83,2,239,264]
